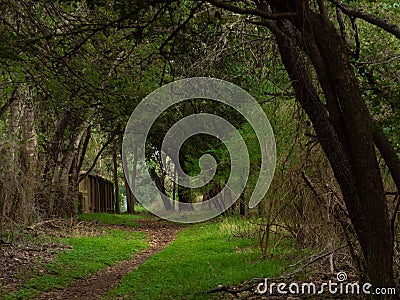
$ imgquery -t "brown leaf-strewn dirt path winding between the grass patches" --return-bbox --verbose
[36,219,182,300]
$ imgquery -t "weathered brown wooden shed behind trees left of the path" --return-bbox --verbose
[79,174,115,213]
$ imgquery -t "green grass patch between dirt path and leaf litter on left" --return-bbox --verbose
[4,229,148,300]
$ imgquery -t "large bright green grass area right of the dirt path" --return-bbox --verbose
[107,221,296,300]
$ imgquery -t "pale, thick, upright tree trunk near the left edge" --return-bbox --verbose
[6,84,37,222]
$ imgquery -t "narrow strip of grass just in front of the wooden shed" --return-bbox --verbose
[78,213,146,227]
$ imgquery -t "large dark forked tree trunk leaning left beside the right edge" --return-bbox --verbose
[267,0,394,286]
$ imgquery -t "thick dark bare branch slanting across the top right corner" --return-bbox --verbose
[328,0,400,39]
